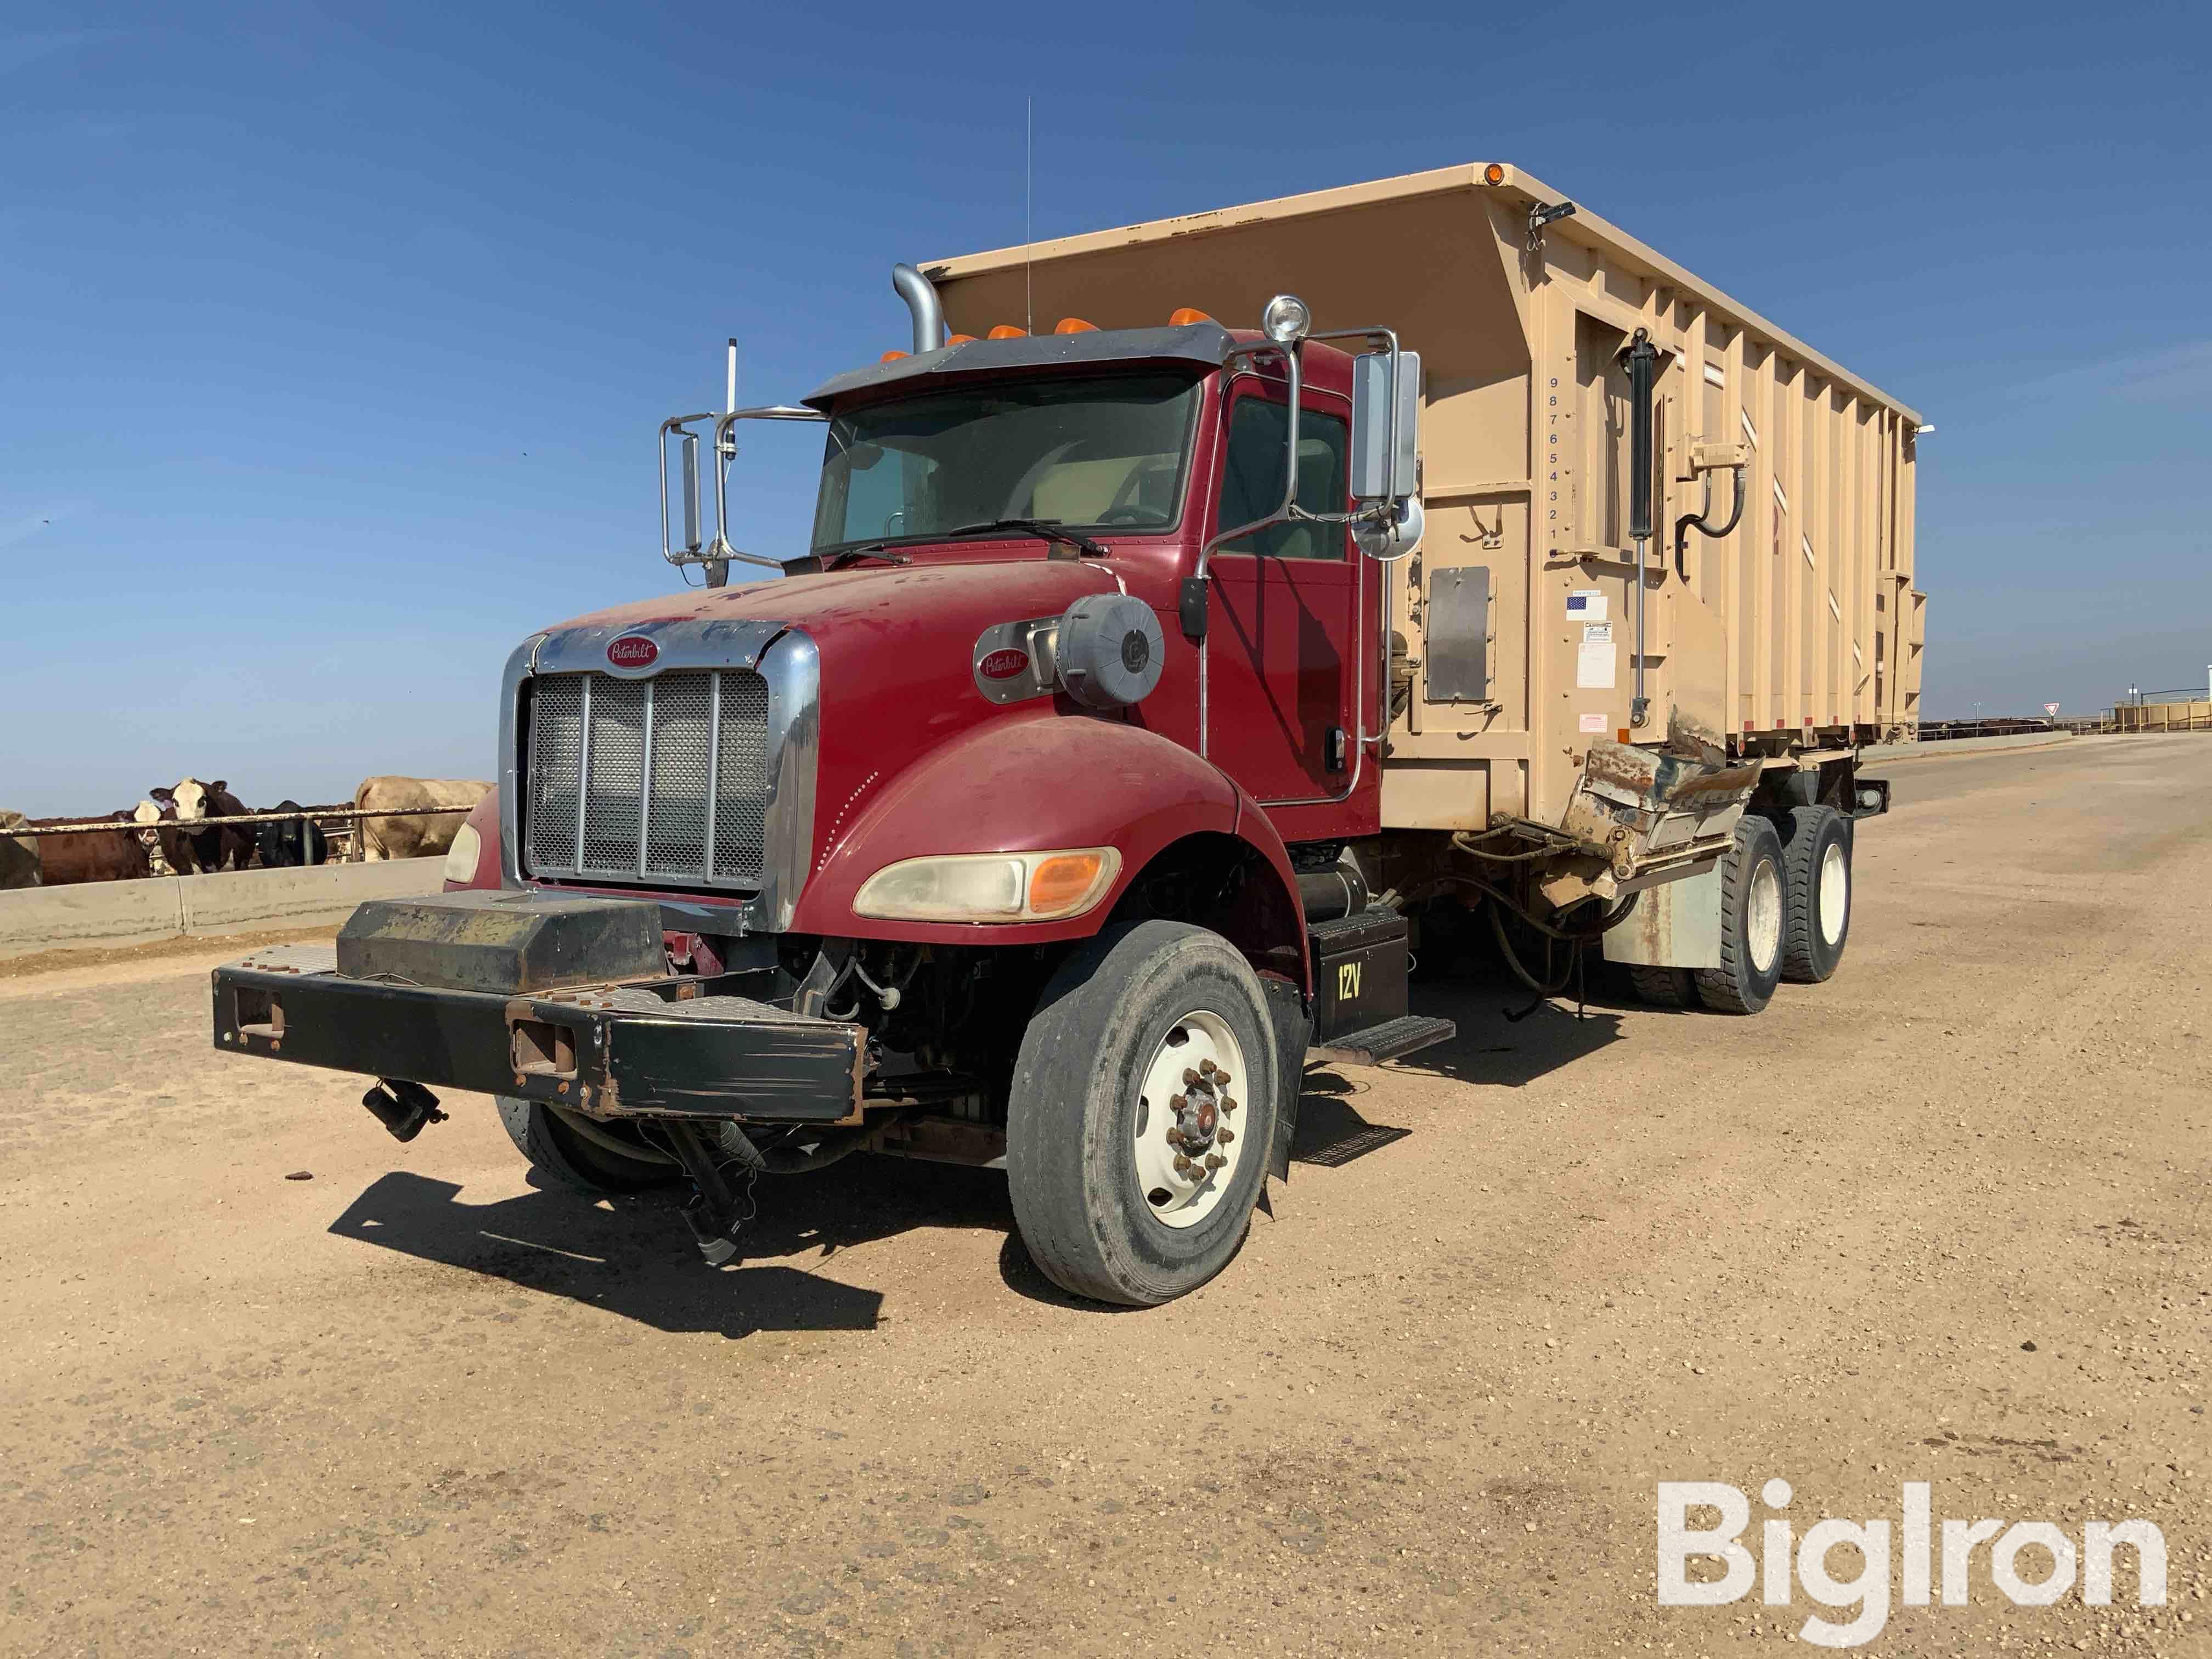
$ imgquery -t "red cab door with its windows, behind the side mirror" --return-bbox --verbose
[1205,381,1361,805]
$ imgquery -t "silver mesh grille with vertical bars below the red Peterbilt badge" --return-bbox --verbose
[522,668,768,885]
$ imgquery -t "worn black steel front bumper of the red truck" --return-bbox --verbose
[215,945,867,1124]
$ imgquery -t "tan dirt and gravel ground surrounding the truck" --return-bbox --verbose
[0,737,2212,1655]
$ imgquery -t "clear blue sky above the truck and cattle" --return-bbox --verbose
[0,0,2212,812]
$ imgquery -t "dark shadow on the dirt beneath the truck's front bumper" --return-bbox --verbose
[330,1157,1013,1338]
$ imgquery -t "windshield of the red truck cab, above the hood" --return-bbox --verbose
[814,374,1199,553]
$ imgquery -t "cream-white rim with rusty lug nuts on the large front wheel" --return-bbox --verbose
[1132,1009,1250,1228]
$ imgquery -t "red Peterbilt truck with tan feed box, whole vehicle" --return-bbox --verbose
[215,163,1922,1305]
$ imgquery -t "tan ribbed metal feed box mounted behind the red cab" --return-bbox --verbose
[924,163,1925,830]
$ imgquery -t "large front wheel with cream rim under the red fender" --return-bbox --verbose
[1007,920,1278,1307]
